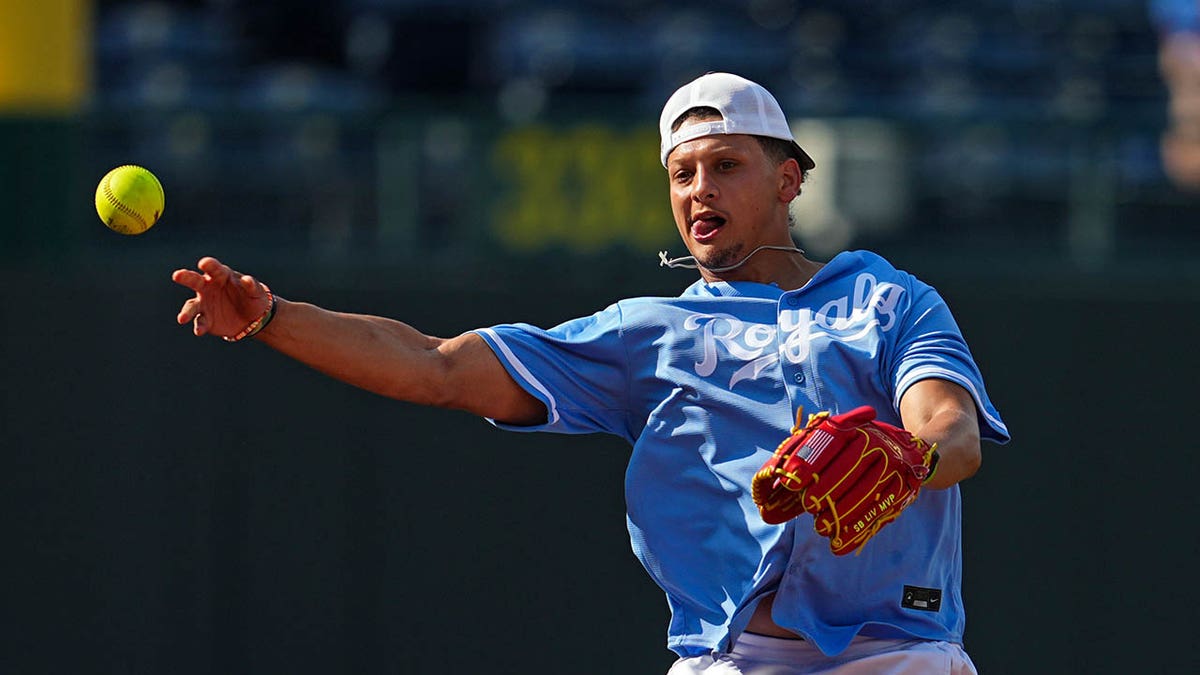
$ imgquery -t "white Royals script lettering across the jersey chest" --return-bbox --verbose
[683,273,904,389]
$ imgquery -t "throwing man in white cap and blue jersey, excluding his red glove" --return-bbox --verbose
[174,73,1008,674]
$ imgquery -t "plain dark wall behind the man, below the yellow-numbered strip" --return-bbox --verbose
[9,254,1200,673]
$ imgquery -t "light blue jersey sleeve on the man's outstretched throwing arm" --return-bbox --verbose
[474,305,632,442]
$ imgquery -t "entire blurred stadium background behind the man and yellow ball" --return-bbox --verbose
[0,0,1200,674]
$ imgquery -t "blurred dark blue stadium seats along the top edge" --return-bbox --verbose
[96,0,1162,117]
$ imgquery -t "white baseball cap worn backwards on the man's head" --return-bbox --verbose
[659,72,817,171]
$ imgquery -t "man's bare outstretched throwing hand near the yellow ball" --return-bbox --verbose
[170,257,270,338]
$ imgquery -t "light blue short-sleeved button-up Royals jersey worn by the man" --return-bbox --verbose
[476,252,1008,656]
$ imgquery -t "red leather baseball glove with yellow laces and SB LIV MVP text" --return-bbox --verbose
[752,406,937,555]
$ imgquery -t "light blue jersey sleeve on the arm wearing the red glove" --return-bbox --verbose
[888,281,1009,443]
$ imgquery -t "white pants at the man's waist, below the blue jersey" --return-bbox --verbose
[667,633,978,675]
